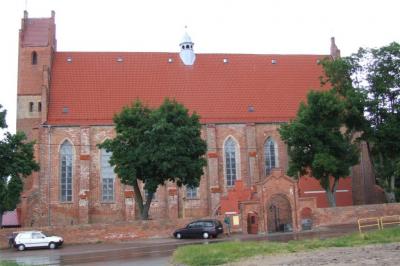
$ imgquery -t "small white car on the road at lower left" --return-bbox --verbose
[13,231,64,251]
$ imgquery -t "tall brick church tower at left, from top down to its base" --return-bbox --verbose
[17,11,57,225]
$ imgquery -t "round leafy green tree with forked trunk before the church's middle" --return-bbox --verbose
[99,99,206,219]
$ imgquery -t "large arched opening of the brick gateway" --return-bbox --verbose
[266,194,293,233]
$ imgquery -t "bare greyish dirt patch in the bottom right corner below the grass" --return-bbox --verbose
[226,243,400,266]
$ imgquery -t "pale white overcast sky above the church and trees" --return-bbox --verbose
[0,0,400,132]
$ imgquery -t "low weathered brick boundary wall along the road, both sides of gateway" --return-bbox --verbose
[0,202,400,249]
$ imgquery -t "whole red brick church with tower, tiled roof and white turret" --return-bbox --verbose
[17,11,382,231]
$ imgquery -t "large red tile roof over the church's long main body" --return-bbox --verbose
[48,52,325,125]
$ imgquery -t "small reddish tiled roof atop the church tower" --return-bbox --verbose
[22,18,53,46]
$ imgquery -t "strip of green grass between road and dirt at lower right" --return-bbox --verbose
[172,227,400,266]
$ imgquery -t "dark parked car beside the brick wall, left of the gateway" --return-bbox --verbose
[173,219,224,239]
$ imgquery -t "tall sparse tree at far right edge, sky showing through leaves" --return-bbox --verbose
[351,42,400,202]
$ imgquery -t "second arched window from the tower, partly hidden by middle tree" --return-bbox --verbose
[100,149,115,201]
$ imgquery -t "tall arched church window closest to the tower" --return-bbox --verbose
[60,141,73,202]
